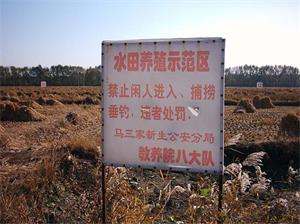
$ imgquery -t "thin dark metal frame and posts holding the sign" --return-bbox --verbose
[101,38,225,223]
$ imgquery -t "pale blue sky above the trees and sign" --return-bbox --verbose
[0,0,300,68]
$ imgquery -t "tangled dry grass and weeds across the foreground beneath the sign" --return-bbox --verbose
[0,151,299,223]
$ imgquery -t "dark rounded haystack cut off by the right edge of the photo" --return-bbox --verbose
[279,113,300,136]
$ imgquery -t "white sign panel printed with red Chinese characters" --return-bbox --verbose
[102,38,225,173]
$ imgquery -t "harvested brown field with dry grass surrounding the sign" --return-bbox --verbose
[0,87,300,224]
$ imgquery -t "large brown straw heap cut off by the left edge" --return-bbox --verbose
[0,101,45,121]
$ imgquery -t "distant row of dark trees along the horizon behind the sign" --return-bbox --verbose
[0,65,300,87]
